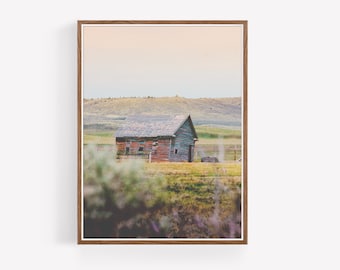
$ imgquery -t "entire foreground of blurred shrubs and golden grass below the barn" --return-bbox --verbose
[83,146,241,238]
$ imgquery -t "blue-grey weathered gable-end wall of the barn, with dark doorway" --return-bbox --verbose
[169,120,195,162]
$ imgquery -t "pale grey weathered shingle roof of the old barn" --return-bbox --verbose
[116,115,197,138]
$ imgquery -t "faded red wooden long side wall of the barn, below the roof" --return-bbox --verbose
[116,137,170,162]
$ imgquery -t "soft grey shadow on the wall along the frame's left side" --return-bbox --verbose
[54,21,77,244]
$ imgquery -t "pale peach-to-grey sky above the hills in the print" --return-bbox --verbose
[83,25,243,98]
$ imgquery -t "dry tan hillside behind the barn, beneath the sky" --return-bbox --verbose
[83,97,241,130]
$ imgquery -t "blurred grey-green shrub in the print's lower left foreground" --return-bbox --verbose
[84,146,167,238]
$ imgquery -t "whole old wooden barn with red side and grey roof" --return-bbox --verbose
[116,115,198,162]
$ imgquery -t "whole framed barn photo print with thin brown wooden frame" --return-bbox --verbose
[78,21,247,244]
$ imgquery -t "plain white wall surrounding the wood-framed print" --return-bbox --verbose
[0,0,340,269]
